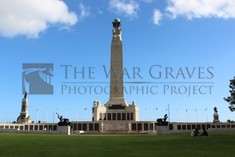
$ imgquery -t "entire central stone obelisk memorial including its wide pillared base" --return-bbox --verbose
[92,18,139,122]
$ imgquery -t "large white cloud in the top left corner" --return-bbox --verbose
[0,0,77,37]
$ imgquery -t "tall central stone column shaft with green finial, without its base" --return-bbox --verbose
[110,18,124,104]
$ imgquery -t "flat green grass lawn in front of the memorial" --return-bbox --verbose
[0,133,235,157]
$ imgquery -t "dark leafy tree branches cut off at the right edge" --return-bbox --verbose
[224,77,235,112]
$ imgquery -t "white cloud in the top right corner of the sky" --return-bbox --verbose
[166,0,235,19]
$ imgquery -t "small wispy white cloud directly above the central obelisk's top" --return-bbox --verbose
[109,0,139,17]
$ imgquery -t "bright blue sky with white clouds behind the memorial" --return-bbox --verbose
[0,0,235,122]
